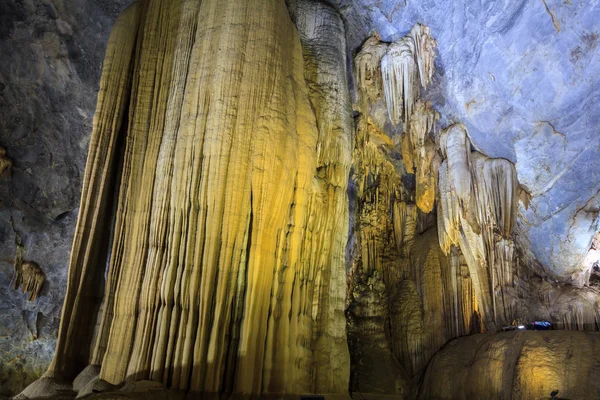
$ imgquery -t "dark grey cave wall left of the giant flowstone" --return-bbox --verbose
[0,0,131,397]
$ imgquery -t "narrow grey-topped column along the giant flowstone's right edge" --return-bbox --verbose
[294,0,354,393]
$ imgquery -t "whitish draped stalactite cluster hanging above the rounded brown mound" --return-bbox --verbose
[438,124,518,331]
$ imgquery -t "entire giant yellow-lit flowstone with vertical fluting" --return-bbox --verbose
[37,0,352,393]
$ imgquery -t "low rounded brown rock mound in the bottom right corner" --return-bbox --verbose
[419,331,600,400]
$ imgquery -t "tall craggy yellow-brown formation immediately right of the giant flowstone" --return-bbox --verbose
[348,27,481,397]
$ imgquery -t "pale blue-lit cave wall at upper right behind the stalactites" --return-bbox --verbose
[330,0,600,285]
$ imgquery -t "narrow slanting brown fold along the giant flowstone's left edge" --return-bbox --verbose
[46,4,140,377]
